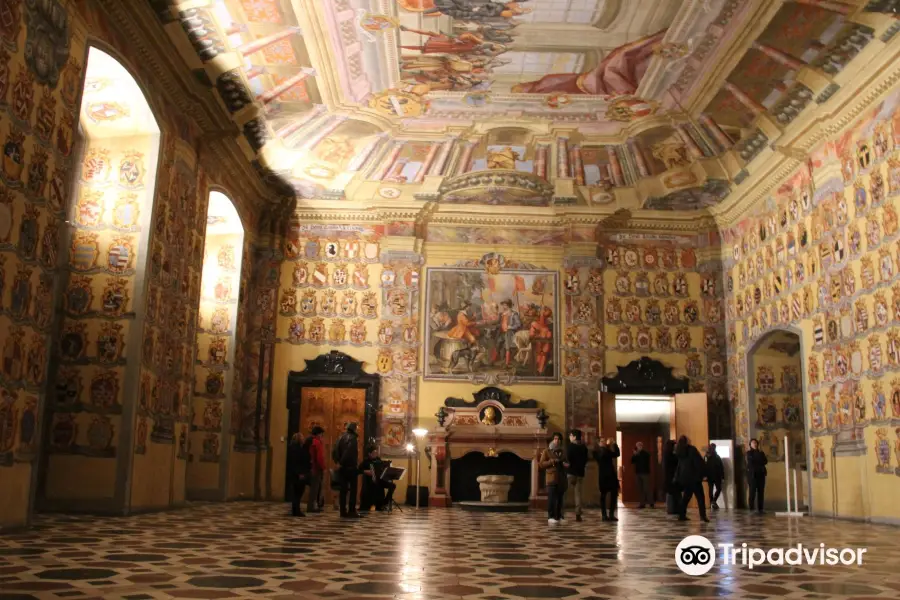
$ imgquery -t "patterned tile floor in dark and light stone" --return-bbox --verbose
[0,503,900,600]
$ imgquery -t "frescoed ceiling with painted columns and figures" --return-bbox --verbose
[149,0,898,211]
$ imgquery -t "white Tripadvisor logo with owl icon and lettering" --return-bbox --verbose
[675,535,868,576]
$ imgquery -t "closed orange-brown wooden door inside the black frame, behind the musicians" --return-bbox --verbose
[298,387,366,504]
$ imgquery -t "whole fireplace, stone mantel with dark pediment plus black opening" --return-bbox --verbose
[428,387,548,510]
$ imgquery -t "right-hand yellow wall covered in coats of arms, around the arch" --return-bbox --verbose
[725,86,900,519]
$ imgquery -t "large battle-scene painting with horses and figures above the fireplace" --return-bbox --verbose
[425,254,559,385]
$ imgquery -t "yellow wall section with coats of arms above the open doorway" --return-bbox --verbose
[600,232,731,438]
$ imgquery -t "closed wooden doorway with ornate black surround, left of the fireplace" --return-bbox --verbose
[284,350,381,504]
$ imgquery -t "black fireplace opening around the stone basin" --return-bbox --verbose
[450,451,531,502]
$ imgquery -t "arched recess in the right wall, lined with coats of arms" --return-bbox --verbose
[747,330,808,510]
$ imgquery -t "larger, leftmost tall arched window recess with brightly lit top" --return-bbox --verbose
[38,47,160,512]
